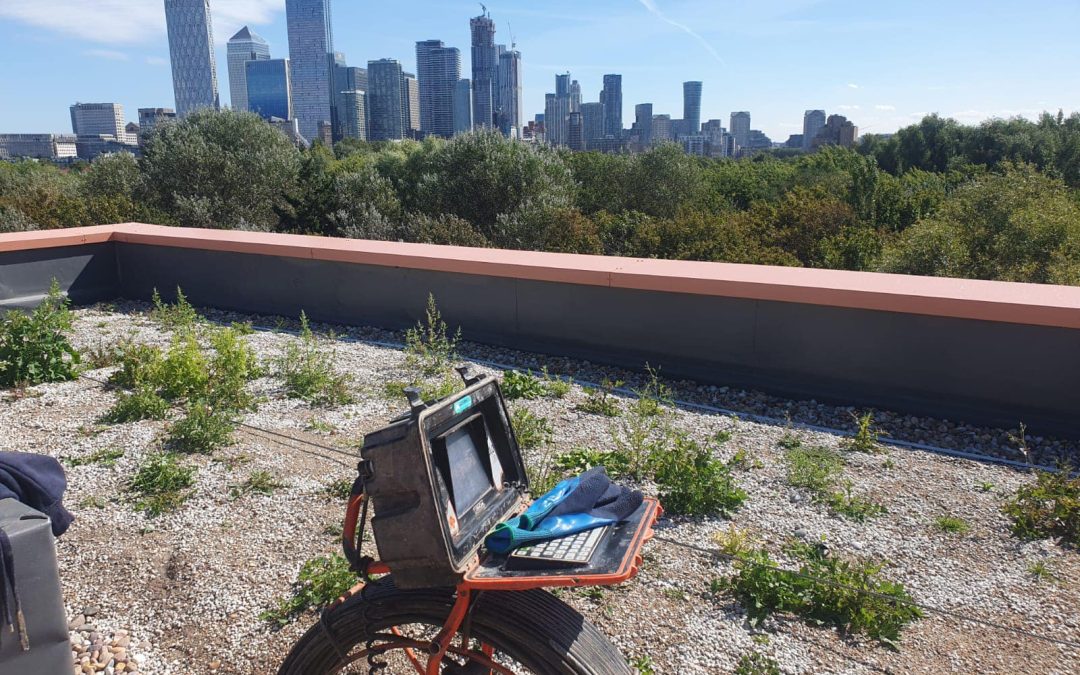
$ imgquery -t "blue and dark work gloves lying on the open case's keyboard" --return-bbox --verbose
[485,467,643,553]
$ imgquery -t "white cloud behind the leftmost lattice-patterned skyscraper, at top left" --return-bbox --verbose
[0,0,285,44]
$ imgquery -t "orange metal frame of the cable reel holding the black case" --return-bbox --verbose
[338,495,663,675]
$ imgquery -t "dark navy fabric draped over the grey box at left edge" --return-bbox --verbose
[0,453,75,537]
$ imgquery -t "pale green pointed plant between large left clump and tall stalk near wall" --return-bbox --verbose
[276,312,352,406]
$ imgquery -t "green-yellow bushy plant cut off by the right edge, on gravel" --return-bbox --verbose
[1003,464,1080,546]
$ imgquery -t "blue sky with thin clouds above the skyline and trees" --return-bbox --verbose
[0,0,1080,140]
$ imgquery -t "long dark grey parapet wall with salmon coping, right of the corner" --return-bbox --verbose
[0,226,1080,437]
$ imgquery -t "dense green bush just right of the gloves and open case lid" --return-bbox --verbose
[656,433,746,517]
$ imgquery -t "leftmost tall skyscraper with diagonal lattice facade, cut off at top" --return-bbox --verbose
[165,0,220,117]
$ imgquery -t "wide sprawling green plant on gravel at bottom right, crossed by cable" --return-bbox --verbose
[726,544,923,648]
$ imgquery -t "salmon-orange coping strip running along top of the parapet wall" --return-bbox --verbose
[0,222,1080,328]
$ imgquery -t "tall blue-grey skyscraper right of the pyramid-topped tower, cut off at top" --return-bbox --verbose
[285,0,335,140]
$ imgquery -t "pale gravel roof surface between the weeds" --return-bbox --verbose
[0,303,1080,675]
